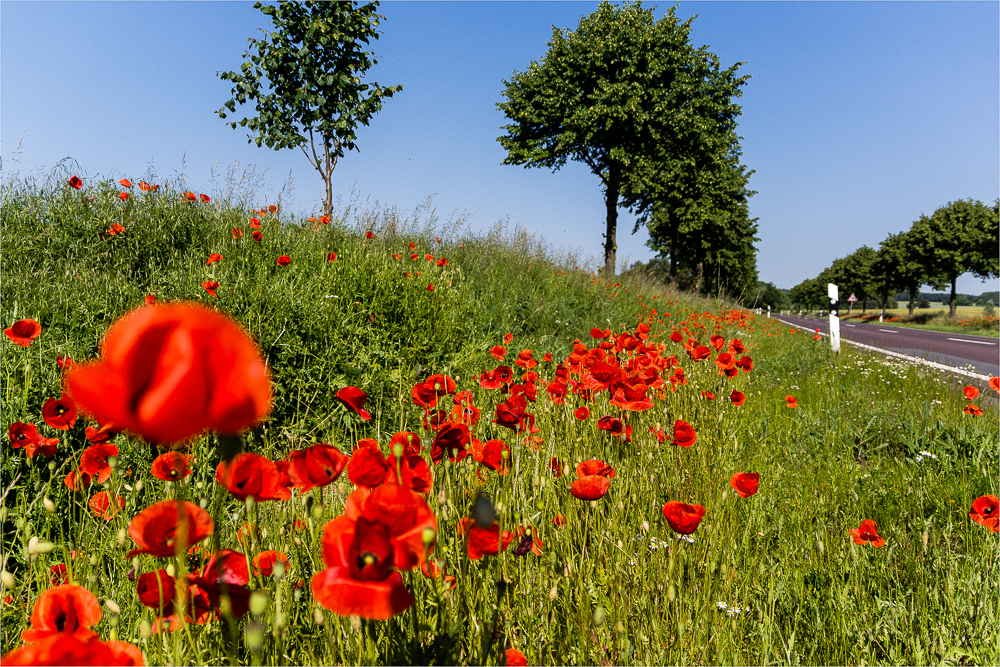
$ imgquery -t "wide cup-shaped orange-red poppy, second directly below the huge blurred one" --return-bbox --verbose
[126,500,215,558]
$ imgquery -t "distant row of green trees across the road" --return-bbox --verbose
[788,199,1000,318]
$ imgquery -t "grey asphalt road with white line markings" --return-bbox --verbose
[772,315,1000,376]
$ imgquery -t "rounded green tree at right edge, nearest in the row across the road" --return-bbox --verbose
[909,199,1000,318]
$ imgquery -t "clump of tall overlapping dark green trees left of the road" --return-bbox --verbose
[497,2,756,286]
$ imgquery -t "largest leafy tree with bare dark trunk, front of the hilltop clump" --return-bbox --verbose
[497,2,753,276]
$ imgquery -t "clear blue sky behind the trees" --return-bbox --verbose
[0,0,1000,294]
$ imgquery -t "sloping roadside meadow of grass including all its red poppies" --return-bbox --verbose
[0,174,1000,665]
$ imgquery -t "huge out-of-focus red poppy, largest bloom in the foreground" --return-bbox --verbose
[66,303,271,443]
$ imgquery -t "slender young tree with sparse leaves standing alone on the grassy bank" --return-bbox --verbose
[216,0,403,216]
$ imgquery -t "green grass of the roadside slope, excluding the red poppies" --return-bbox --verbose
[0,175,1000,664]
